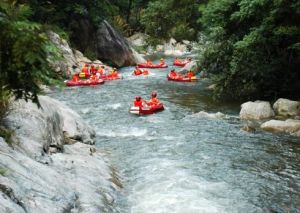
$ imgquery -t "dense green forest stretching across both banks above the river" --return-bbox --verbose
[0,0,300,113]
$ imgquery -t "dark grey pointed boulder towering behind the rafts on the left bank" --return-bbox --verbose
[96,21,144,66]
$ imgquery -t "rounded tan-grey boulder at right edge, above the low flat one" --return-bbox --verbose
[273,98,300,116]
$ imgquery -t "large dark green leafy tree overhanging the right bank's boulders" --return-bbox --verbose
[200,0,300,99]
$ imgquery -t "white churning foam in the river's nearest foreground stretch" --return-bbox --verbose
[128,159,227,213]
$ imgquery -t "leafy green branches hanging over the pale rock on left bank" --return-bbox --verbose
[0,0,56,105]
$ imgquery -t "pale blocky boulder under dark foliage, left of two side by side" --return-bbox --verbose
[240,101,275,120]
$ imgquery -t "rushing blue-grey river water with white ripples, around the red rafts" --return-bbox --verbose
[51,58,300,213]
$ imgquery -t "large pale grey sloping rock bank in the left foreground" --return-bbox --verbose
[0,96,120,212]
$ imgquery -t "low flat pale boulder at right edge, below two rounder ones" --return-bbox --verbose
[261,119,300,136]
